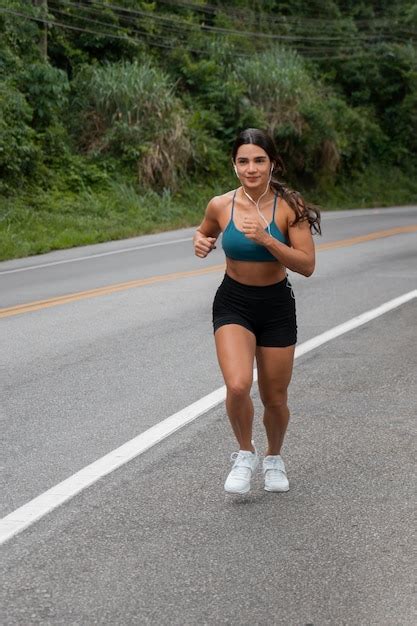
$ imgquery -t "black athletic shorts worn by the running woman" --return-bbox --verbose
[213,274,297,348]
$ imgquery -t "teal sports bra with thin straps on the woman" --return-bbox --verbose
[222,190,289,262]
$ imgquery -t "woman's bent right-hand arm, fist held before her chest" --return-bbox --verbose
[243,205,316,276]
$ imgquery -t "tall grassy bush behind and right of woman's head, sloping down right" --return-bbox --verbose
[236,47,388,184]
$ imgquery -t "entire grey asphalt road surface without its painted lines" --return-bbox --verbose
[0,207,417,626]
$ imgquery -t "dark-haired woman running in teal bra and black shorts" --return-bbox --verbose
[194,128,320,494]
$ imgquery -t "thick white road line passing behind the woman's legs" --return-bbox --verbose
[0,289,417,545]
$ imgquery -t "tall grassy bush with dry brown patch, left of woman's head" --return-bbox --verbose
[72,60,192,187]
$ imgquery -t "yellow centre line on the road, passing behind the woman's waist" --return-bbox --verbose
[0,224,417,318]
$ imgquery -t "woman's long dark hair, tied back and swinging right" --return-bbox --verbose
[232,128,321,235]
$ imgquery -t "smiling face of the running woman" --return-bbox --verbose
[235,143,272,189]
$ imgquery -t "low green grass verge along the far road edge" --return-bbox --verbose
[0,169,417,260]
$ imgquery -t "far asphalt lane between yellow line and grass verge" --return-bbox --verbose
[0,206,417,307]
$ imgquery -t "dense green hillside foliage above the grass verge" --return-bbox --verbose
[0,0,417,256]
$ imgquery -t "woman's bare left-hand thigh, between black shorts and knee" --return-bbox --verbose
[214,324,256,388]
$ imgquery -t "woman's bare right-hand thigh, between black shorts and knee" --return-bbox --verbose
[256,346,295,404]
